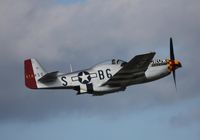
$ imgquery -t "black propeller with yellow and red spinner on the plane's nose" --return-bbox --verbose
[170,37,182,89]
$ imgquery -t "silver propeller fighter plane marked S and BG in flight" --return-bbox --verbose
[24,38,182,96]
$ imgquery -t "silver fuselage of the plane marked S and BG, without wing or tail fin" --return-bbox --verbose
[37,60,171,95]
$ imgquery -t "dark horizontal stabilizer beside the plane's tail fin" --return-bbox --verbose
[38,71,58,83]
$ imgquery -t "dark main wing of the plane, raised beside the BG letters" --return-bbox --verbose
[103,52,156,86]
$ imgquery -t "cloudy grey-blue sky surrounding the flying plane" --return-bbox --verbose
[0,0,200,140]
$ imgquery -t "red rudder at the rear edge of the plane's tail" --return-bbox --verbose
[24,59,37,89]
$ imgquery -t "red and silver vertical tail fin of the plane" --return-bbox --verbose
[24,59,46,89]
